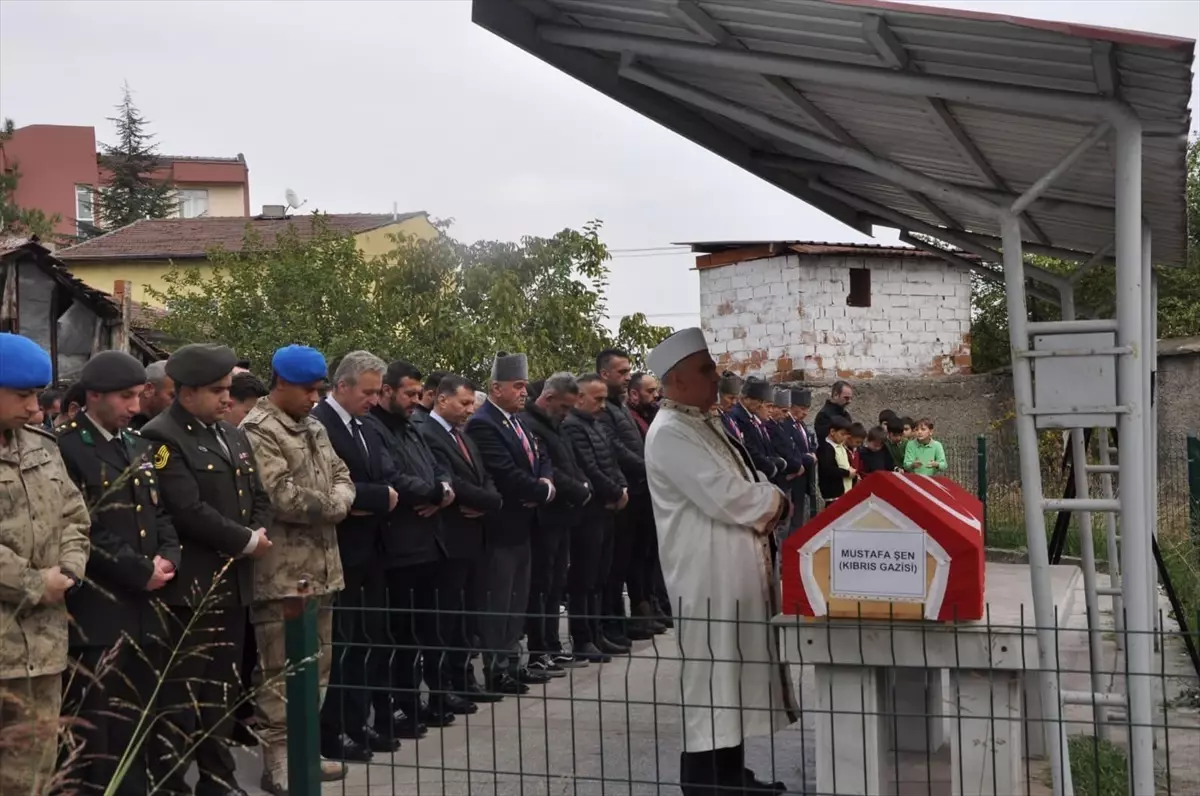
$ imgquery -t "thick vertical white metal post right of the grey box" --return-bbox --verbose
[1115,119,1154,794]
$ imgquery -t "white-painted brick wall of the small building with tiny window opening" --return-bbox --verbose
[700,255,971,381]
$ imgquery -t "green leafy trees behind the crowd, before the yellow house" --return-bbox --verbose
[150,215,671,382]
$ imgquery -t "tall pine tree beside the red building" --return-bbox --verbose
[96,84,179,231]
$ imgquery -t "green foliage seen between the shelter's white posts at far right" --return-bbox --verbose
[971,140,1200,372]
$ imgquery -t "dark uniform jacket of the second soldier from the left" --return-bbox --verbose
[58,412,180,648]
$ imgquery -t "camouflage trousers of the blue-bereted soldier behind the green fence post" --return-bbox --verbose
[250,594,334,752]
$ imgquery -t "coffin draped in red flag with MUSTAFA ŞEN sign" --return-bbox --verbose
[780,472,986,622]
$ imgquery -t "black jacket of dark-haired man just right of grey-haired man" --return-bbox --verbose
[366,406,450,567]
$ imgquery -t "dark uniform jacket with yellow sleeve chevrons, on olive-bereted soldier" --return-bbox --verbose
[142,401,271,608]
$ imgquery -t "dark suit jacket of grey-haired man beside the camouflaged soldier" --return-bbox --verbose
[312,401,396,569]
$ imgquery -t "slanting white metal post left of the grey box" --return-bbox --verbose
[1003,216,1073,796]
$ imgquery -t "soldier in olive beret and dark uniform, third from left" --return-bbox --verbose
[142,343,271,796]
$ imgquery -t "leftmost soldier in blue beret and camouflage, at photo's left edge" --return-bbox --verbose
[0,334,89,796]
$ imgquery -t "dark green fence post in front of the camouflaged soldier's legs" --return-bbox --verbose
[283,597,319,796]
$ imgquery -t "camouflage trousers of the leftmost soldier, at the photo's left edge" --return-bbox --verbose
[0,675,62,796]
